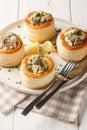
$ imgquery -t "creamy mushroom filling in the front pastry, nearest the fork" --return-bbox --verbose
[27,56,49,73]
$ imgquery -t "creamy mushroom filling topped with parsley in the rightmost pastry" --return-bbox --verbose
[64,29,86,46]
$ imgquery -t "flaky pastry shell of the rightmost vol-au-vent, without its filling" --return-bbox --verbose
[57,28,87,61]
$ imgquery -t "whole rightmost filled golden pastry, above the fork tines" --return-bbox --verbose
[57,27,87,61]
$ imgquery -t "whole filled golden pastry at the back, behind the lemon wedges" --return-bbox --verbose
[24,11,56,42]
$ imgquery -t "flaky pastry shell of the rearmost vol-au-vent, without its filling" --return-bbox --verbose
[24,12,56,42]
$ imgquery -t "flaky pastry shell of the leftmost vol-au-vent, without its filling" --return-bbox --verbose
[0,34,25,67]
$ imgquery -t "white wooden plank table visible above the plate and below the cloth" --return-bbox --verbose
[0,0,87,130]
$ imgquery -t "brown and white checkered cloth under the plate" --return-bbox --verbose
[0,79,87,123]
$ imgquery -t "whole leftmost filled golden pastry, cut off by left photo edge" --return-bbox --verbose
[0,33,25,67]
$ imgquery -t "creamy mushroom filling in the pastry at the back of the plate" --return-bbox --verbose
[29,11,51,25]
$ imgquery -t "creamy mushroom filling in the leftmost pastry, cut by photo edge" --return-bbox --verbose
[0,33,18,50]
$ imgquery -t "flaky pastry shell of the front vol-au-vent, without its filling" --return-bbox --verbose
[20,56,55,89]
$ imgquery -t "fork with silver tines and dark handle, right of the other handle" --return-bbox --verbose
[35,62,77,109]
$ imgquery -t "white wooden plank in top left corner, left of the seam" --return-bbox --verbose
[0,0,18,29]
